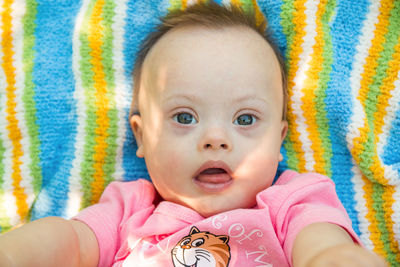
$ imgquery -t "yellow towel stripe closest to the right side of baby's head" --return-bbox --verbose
[287,0,306,172]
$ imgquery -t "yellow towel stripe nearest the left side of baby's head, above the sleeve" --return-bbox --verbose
[88,0,110,203]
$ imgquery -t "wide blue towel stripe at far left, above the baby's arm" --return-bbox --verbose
[32,0,80,220]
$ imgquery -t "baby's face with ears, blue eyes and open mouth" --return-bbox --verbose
[131,27,287,217]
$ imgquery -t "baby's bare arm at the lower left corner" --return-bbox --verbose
[0,217,99,267]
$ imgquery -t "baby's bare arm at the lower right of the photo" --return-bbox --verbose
[292,223,387,267]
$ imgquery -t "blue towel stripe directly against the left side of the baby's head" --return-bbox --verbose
[122,0,169,180]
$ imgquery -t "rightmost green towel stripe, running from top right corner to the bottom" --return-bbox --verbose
[359,1,400,264]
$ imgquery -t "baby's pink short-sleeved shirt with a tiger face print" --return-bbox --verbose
[75,171,360,267]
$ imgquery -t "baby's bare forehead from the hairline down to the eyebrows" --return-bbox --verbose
[139,26,282,116]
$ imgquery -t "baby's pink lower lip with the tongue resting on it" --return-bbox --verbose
[193,173,233,193]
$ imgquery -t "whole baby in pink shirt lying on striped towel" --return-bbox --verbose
[0,1,386,267]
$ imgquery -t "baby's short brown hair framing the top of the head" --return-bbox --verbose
[130,0,287,119]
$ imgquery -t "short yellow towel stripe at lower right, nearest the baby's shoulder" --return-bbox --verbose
[362,175,387,258]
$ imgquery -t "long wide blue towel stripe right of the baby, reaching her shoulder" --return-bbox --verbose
[325,0,369,234]
